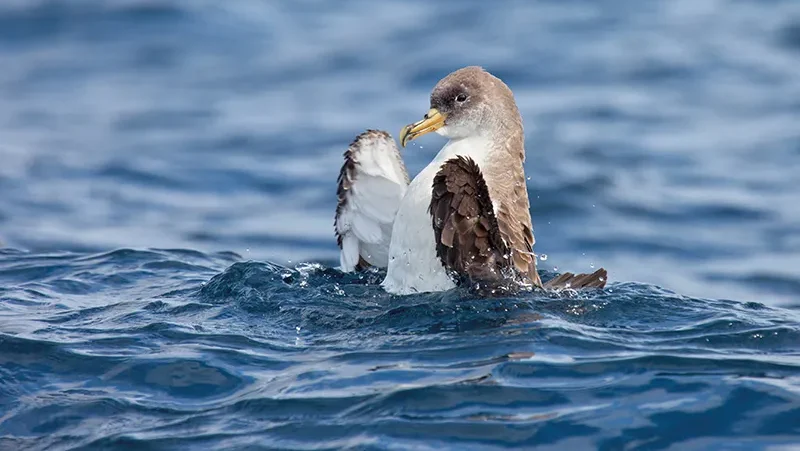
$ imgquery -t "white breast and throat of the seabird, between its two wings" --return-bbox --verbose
[382,137,490,294]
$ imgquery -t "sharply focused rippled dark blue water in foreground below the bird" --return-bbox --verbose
[0,250,800,449]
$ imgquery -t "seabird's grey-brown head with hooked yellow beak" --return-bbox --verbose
[400,66,522,147]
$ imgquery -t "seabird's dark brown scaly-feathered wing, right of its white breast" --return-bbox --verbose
[428,156,511,281]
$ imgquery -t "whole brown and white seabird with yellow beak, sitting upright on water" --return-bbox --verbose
[334,67,607,294]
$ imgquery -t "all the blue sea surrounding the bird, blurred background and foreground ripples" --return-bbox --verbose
[0,0,800,451]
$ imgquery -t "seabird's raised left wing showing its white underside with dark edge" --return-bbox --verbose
[334,130,409,271]
